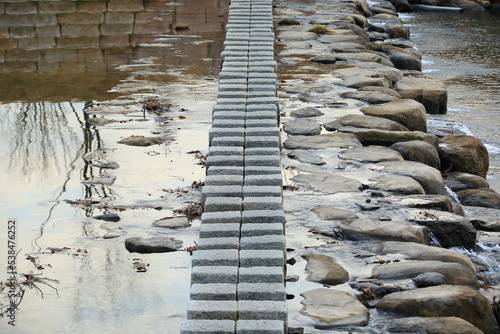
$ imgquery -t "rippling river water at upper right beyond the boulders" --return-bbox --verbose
[400,7,500,192]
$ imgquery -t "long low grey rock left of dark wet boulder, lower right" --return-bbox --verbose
[340,219,429,244]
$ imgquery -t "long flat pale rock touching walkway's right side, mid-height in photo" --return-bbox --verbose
[283,133,362,149]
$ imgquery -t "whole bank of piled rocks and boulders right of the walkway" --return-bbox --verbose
[275,0,500,333]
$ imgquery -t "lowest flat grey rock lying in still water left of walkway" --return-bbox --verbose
[125,237,182,254]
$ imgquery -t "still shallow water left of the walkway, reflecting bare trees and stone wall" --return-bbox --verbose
[0,0,228,333]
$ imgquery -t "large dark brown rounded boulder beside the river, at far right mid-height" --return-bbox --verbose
[438,135,490,178]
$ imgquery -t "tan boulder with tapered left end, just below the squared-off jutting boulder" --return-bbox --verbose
[361,99,427,132]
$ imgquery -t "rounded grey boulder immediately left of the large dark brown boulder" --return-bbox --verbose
[391,140,441,169]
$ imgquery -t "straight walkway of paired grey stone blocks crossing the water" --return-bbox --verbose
[181,0,287,334]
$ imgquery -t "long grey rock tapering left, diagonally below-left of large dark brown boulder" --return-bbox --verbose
[376,161,446,195]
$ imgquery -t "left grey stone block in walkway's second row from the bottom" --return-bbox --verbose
[187,300,238,320]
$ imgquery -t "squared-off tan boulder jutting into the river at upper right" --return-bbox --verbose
[394,77,448,114]
